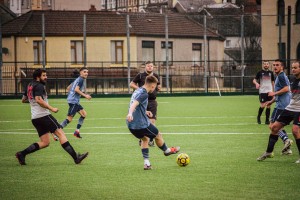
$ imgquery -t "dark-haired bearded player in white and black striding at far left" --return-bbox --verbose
[16,69,88,165]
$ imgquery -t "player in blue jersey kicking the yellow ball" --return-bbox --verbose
[126,75,180,170]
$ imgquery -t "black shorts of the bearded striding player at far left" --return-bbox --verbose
[31,115,61,137]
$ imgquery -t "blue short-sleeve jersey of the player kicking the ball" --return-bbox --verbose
[126,87,150,129]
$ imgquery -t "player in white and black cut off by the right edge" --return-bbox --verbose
[257,60,300,164]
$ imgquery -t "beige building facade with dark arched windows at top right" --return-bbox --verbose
[261,0,300,64]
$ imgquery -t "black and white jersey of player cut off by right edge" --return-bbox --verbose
[285,77,300,112]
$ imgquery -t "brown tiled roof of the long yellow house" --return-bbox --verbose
[2,11,223,40]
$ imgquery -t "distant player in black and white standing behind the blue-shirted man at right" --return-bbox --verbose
[253,61,274,124]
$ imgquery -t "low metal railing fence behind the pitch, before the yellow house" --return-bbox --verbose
[1,61,261,96]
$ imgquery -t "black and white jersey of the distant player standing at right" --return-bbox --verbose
[255,70,275,94]
